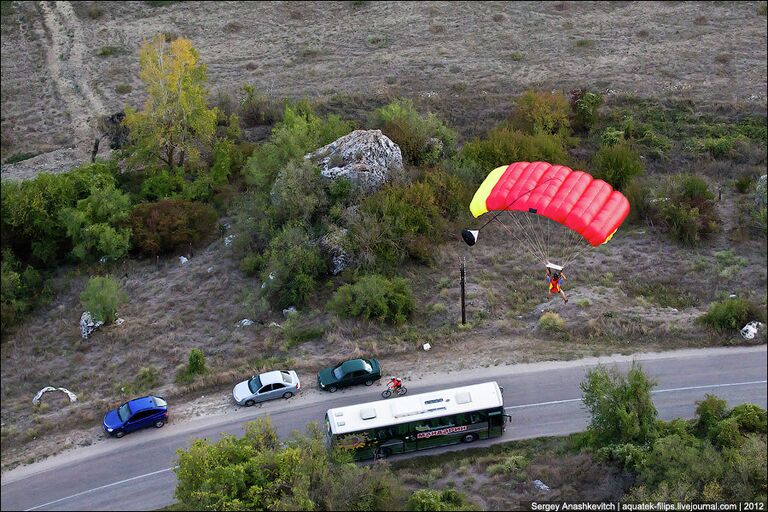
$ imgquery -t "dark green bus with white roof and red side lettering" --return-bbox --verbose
[325,382,509,460]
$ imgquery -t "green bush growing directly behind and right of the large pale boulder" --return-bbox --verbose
[371,99,457,166]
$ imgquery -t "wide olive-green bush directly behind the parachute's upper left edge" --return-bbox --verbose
[453,126,568,186]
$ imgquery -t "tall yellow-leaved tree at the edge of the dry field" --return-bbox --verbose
[125,36,216,169]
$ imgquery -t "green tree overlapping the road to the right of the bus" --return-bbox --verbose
[580,362,656,446]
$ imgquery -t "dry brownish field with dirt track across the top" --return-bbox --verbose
[2,2,766,158]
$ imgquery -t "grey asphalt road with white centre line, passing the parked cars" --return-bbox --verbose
[0,345,766,510]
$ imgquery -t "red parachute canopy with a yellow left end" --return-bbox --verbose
[469,162,629,247]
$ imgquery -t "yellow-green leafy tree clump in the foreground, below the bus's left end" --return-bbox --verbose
[175,419,401,510]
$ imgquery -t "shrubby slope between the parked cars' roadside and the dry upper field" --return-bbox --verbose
[0,32,766,468]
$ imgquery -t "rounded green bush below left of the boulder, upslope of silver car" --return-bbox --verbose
[262,222,327,309]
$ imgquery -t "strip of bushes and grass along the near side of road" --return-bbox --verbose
[170,364,768,511]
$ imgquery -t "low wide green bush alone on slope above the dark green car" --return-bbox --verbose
[328,275,416,324]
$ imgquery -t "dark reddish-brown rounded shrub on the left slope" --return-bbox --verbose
[129,199,218,255]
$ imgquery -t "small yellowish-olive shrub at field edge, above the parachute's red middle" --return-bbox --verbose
[510,90,571,137]
